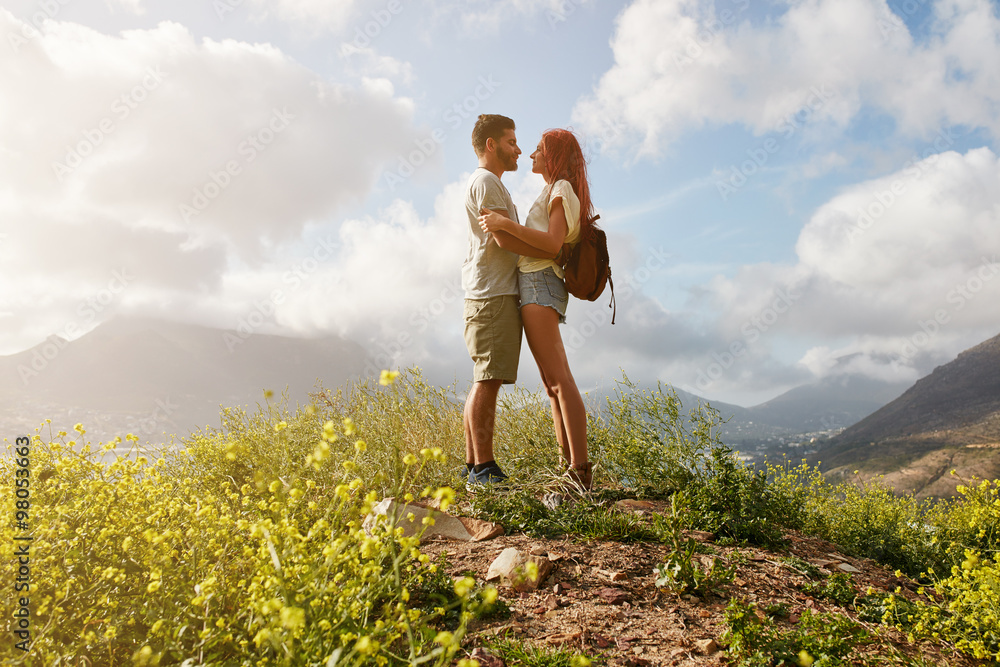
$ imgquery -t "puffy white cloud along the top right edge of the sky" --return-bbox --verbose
[574,0,1000,155]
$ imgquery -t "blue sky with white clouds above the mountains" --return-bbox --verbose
[0,0,1000,406]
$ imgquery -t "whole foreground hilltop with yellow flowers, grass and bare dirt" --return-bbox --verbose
[0,371,1000,667]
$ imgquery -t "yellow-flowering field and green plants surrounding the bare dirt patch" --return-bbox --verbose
[0,371,1000,667]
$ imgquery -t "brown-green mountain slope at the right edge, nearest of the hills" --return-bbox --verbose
[816,336,1000,496]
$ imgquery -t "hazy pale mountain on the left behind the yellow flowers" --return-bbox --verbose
[0,318,366,442]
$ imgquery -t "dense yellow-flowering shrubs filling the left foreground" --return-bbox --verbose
[0,421,488,667]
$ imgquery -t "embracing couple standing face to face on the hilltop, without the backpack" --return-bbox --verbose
[462,114,593,489]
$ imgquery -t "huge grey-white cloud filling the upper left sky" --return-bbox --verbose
[0,10,417,351]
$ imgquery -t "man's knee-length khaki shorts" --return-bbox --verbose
[465,294,521,384]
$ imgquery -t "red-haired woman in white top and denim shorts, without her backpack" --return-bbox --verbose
[479,130,593,489]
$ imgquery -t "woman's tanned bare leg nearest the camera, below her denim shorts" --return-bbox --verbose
[521,303,588,470]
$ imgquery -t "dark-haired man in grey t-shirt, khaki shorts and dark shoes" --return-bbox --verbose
[462,114,521,486]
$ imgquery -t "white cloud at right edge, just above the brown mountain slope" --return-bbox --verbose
[709,148,1000,386]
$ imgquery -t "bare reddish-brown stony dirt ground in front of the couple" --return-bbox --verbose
[422,501,988,667]
